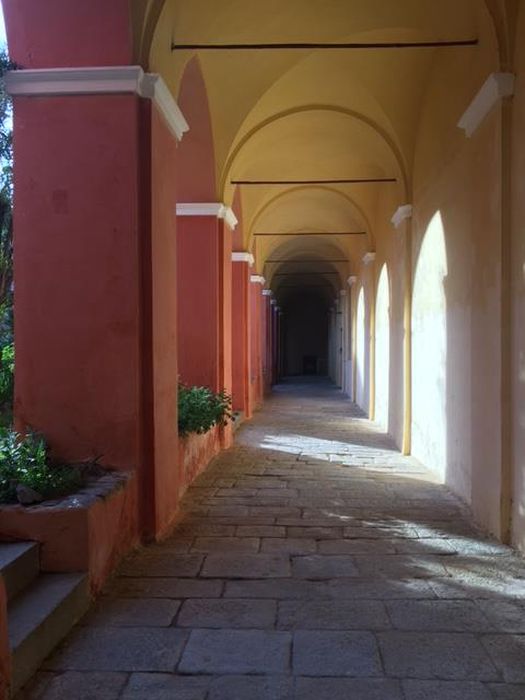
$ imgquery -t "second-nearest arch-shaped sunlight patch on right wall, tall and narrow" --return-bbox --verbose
[375,263,390,431]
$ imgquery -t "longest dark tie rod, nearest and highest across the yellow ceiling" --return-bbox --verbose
[171,38,479,51]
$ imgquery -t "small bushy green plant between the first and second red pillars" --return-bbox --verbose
[178,384,232,435]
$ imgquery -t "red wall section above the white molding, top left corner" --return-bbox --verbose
[2,0,133,68]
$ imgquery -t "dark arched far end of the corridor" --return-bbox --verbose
[283,288,329,376]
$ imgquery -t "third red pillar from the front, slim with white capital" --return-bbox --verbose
[232,252,254,418]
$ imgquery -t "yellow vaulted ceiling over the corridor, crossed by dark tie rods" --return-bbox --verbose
[135,0,496,284]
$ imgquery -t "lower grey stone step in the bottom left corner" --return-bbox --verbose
[8,573,90,694]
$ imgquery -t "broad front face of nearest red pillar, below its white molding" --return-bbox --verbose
[14,95,140,469]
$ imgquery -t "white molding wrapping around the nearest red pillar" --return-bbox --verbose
[5,66,190,141]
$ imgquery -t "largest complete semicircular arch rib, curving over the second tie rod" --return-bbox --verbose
[220,104,409,196]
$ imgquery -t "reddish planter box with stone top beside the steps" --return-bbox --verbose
[0,472,139,593]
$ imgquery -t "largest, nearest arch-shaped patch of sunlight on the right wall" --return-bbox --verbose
[412,212,447,479]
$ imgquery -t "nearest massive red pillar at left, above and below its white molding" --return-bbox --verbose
[3,0,188,536]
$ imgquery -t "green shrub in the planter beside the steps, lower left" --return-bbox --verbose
[0,428,82,503]
